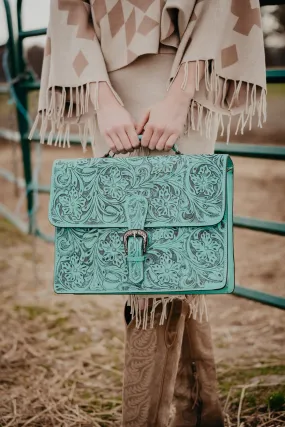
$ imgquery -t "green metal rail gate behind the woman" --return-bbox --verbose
[0,0,285,309]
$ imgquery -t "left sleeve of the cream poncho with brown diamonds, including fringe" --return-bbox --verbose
[30,0,123,154]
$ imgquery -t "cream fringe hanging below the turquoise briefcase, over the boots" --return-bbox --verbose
[127,295,206,329]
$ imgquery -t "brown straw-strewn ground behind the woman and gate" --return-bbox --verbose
[0,88,285,427]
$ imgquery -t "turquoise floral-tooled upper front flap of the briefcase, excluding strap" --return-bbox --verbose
[49,154,226,227]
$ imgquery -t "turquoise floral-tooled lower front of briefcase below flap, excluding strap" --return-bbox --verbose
[55,221,227,293]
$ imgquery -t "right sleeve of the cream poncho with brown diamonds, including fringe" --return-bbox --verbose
[164,0,267,141]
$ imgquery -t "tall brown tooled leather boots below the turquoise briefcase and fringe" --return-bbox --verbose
[122,299,224,427]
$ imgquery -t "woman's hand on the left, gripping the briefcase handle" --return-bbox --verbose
[97,82,140,153]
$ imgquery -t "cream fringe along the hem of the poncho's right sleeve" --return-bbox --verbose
[167,60,267,144]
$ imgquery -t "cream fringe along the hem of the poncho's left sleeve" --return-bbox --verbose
[29,81,124,155]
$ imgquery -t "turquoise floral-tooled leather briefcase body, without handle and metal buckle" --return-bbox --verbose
[49,154,234,295]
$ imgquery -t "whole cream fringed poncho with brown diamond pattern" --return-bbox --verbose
[30,0,266,155]
